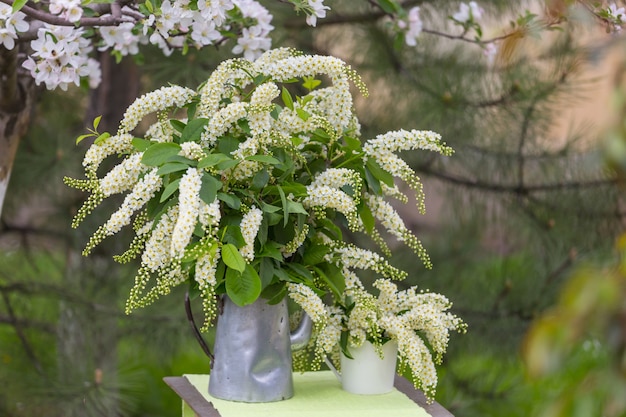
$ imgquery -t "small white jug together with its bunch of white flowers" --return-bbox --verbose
[290,275,467,401]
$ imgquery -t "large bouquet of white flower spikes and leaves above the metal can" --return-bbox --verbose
[65,48,452,380]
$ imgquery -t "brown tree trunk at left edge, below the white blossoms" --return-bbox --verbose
[0,45,38,217]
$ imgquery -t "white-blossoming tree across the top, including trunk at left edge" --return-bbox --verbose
[0,0,624,218]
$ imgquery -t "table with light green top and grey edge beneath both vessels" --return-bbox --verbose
[164,371,454,417]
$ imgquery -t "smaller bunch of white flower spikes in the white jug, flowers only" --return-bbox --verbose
[289,278,467,401]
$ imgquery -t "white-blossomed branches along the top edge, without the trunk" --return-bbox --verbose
[0,0,624,89]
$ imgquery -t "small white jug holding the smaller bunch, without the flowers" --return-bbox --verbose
[326,340,398,395]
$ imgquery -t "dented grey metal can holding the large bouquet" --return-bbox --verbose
[186,290,312,403]
